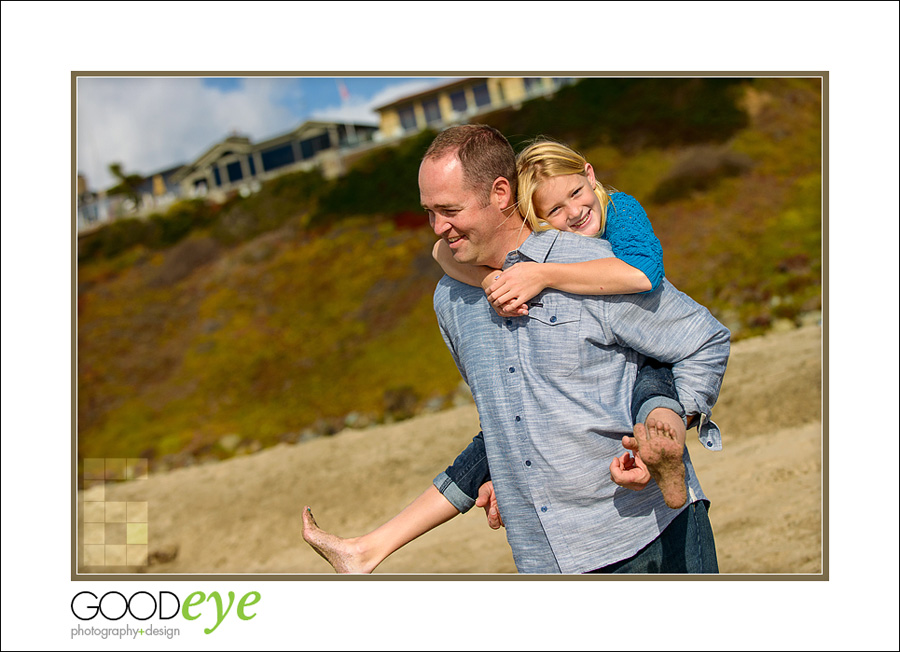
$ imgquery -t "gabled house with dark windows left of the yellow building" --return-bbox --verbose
[172,120,377,201]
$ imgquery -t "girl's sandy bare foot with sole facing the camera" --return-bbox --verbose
[626,412,687,509]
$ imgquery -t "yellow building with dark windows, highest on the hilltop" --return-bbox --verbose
[375,77,572,140]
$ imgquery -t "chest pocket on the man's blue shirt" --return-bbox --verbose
[528,295,582,378]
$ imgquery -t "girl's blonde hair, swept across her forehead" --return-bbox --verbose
[516,140,610,235]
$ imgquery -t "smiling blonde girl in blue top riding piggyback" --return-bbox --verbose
[303,141,687,573]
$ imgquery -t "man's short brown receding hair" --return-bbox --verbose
[423,125,517,204]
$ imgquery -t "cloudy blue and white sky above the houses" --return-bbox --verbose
[77,76,441,190]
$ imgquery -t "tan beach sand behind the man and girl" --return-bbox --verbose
[79,326,825,575]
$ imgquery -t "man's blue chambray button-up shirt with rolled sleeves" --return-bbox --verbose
[434,231,730,573]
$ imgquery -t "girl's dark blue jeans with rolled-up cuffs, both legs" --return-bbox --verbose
[438,359,684,502]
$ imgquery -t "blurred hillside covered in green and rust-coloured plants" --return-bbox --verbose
[77,79,822,471]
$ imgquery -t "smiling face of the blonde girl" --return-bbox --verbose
[532,163,600,235]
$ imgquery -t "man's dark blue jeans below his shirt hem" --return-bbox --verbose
[590,500,719,574]
